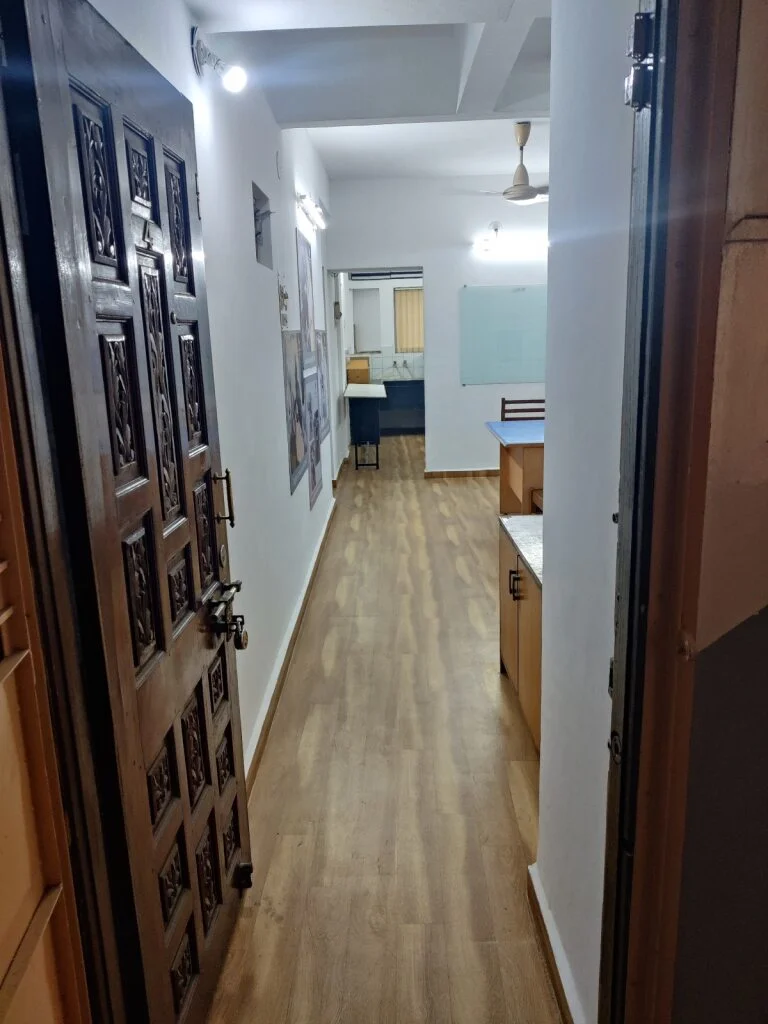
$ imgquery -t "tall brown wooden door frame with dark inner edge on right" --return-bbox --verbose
[599,0,740,1024]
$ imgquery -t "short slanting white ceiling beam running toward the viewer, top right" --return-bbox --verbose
[456,0,547,117]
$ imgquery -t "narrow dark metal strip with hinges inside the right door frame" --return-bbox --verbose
[599,0,678,1024]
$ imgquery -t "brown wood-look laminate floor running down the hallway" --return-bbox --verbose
[210,437,560,1024]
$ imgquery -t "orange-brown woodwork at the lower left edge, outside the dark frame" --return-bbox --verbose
[0,274,91,1024]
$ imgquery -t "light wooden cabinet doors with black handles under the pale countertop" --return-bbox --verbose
[499,527,542,751]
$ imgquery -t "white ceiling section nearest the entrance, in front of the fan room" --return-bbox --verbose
[205,0,551,127]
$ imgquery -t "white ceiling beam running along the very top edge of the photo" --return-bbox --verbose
[195,0,515,33]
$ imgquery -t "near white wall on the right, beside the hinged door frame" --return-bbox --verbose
[531,0,637,1022]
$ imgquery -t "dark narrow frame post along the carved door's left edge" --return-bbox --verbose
[0,44,125,1024]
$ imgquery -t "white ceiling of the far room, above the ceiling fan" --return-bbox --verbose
[309,120,549,185]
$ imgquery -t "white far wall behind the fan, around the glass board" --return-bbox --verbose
[328,177,547,472]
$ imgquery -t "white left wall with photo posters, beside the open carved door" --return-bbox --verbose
[87,0,333,765]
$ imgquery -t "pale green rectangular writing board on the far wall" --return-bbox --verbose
[459,285,547,384]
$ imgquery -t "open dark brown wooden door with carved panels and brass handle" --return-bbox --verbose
[15,0,250,1024]
